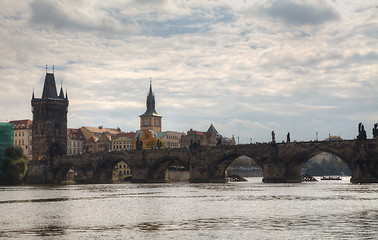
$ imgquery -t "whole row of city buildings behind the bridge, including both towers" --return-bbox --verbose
[2,71,235,164]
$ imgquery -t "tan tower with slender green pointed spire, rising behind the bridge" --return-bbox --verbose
[139,81,162,132]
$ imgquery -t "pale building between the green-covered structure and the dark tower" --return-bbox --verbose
[9,119,33,161]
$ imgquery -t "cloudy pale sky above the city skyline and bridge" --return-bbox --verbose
[0,0,378,143]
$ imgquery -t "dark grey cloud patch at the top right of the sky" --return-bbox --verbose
[247,0,340,25]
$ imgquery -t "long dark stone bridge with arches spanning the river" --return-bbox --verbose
[31,139,378,183]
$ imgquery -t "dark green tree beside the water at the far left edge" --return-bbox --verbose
[0,146,28,185]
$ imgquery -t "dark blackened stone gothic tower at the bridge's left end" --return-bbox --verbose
[31,67,68,162]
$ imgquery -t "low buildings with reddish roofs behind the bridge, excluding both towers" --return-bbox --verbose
[7,119,235,160]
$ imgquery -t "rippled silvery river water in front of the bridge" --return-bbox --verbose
[0,178,378,239]
